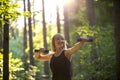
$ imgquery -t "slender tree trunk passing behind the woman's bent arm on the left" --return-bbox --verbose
[42,0,49,80]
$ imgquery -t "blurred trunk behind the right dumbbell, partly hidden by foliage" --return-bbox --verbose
[86,0,98,80]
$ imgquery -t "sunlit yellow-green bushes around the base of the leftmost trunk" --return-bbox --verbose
[0,53,38,80]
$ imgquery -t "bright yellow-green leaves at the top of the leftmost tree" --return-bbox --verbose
[0,0,21,25]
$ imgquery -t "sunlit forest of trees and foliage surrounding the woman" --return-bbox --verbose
[0,0,120,80]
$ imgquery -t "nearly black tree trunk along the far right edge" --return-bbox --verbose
[113,0,120,80]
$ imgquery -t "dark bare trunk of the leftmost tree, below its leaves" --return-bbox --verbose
[3,16,9,80]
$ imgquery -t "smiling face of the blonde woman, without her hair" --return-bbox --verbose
[54,35,64,48]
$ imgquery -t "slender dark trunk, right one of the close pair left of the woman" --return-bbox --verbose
[28,0,34,65]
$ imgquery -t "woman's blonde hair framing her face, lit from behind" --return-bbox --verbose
[52,33,67,52]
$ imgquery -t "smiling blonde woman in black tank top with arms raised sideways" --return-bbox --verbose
[34,33,87,80]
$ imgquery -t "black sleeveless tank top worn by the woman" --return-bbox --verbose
[50,51,71,80]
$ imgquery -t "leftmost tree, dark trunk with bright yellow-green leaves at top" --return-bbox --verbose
[0,0,20,80]
